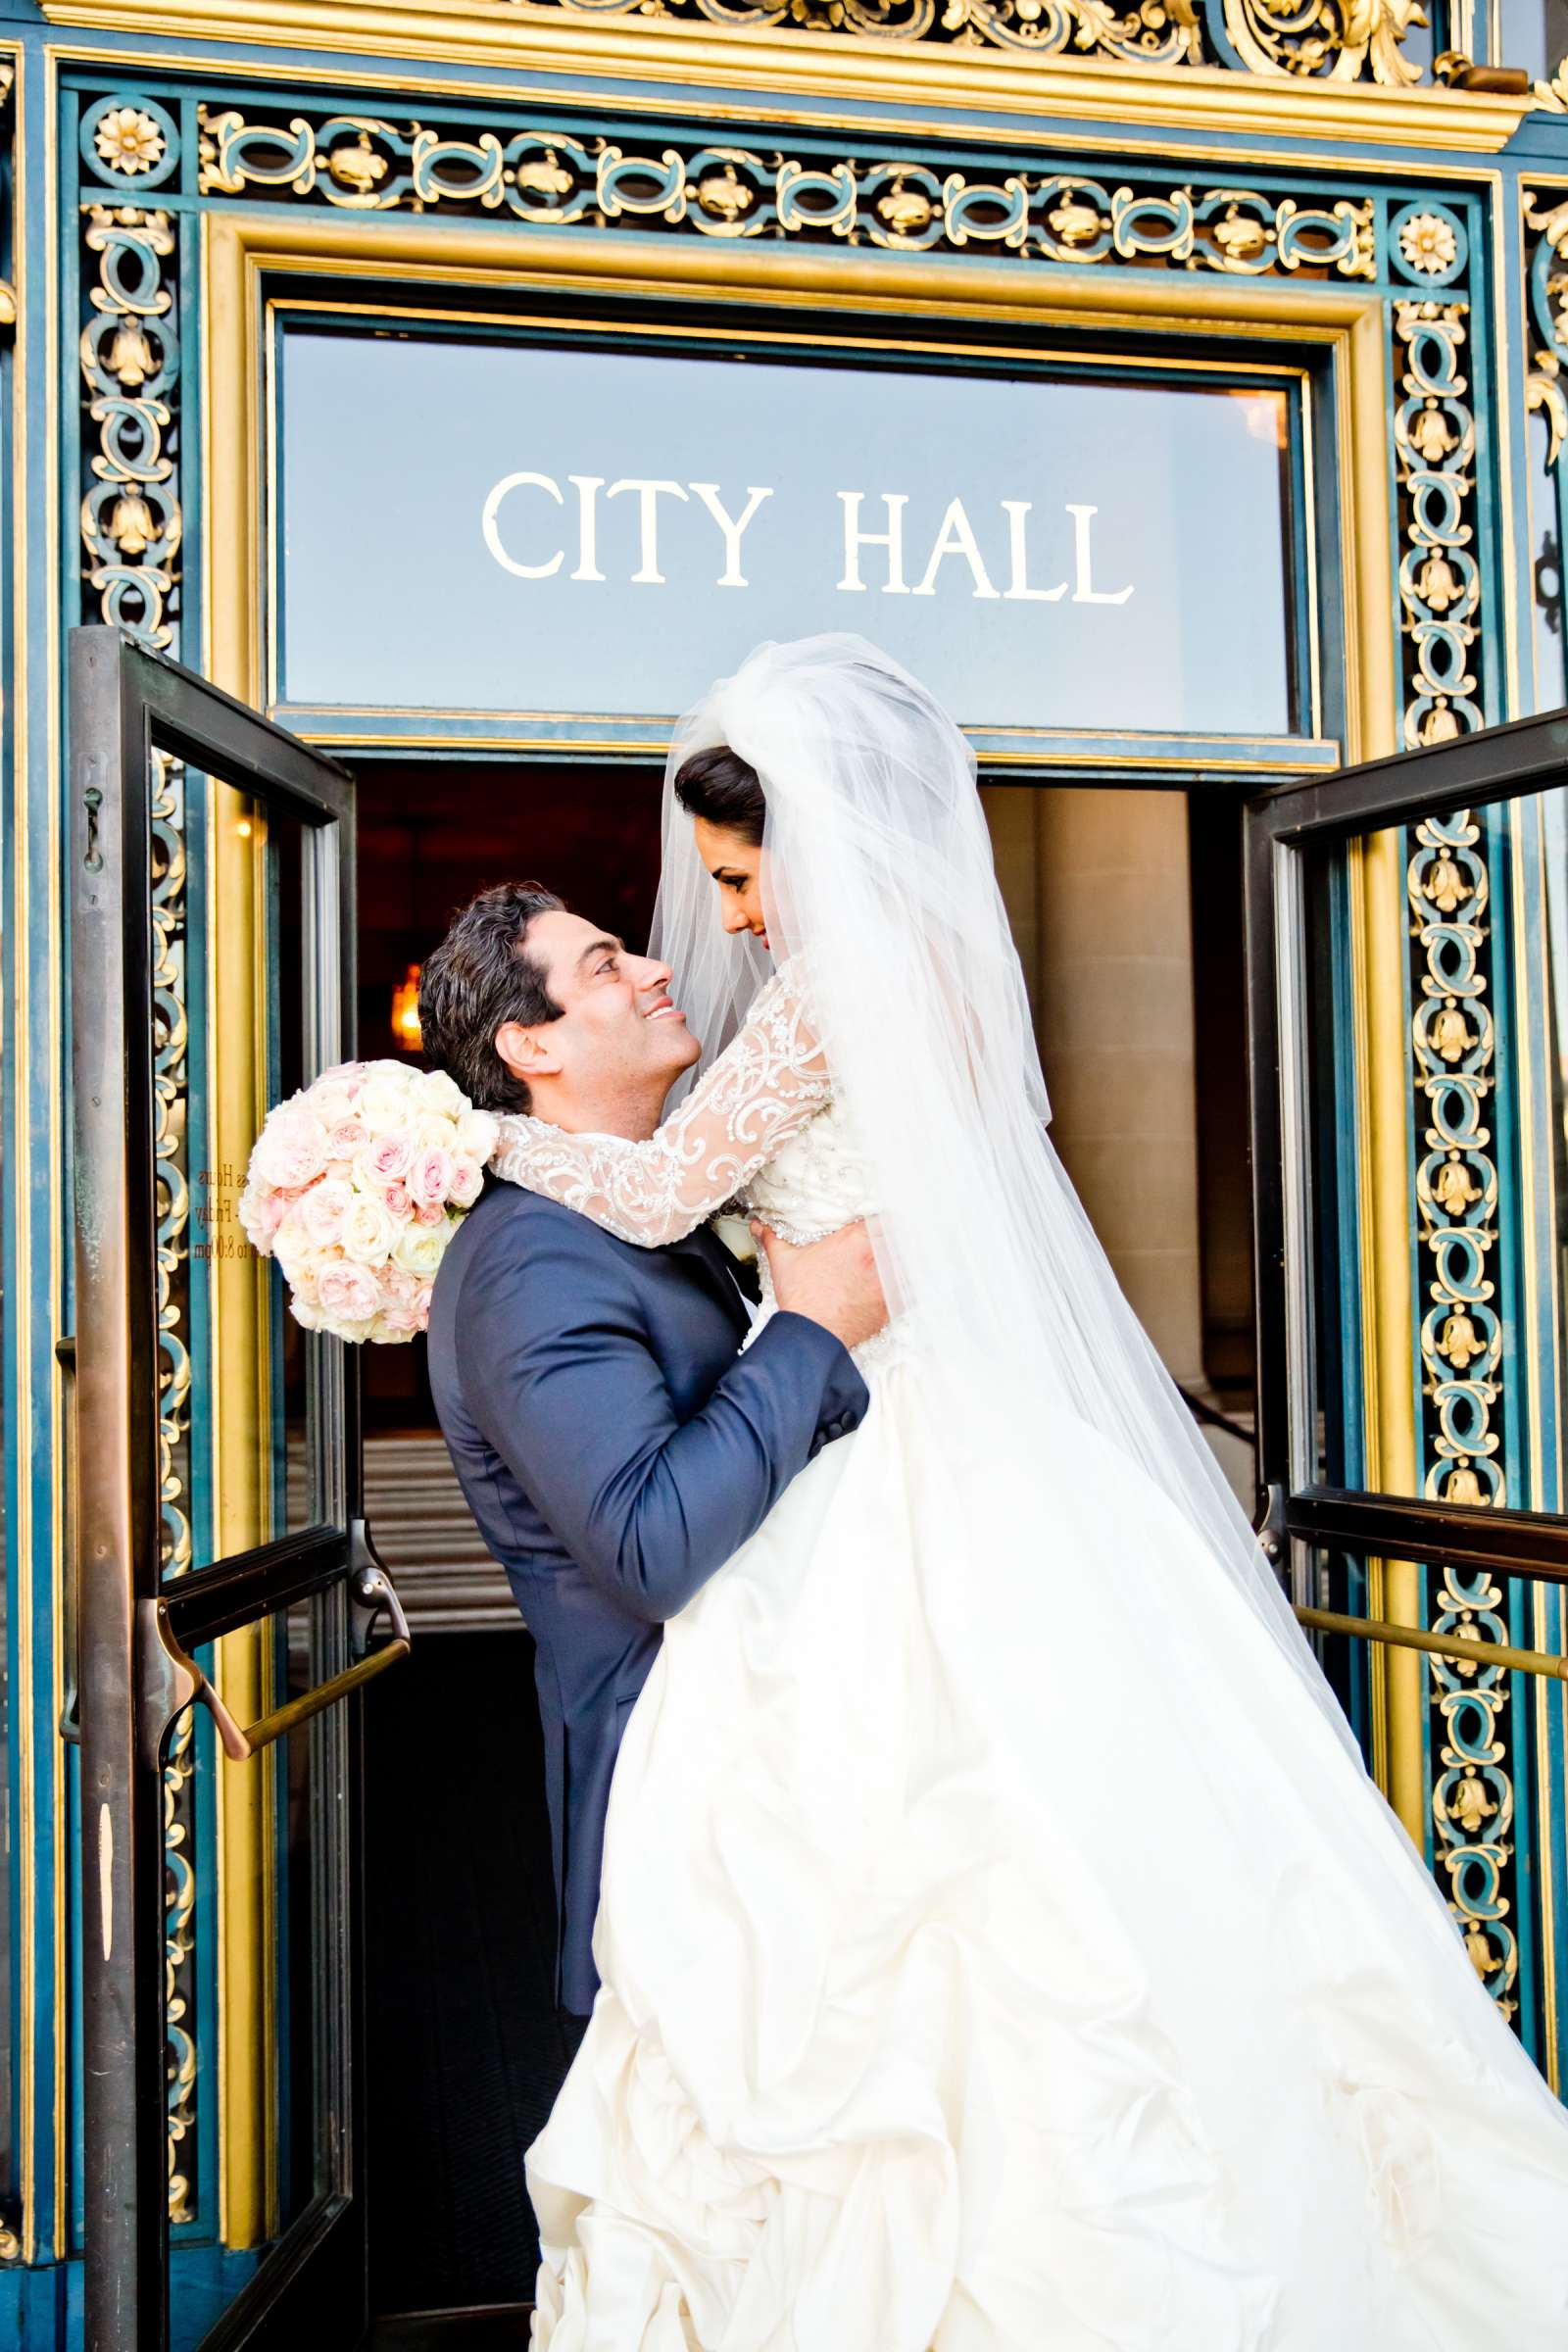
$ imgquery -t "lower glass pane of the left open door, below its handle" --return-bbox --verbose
[170,1599,343,2352]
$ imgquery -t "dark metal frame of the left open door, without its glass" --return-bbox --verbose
[69,625,385,2352]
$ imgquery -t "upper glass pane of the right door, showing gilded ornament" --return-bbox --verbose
[1309,790,1568,1510]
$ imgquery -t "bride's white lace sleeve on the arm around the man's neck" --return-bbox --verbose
[491,971,832,1249]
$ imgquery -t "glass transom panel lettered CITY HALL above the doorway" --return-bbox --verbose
[279,329,1296,734]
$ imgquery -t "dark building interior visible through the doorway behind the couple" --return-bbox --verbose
[358,760,1253,2314]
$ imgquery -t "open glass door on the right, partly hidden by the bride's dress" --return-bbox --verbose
[1246,712,1568,2088]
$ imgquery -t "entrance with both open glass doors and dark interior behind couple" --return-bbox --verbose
[71,630,1568,2352]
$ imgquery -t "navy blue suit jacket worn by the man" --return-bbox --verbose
[430,1183,867,2013]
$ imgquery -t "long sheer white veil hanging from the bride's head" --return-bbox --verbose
[654,635,1354,1750]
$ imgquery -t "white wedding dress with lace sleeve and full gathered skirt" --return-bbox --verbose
[496,974,1568,2352]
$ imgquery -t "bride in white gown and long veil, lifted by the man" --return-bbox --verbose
[496,635,1568,2352]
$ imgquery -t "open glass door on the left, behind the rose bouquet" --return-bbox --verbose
[71,628,409,2352]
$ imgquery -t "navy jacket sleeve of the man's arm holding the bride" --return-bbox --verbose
[459,1216,870,1623]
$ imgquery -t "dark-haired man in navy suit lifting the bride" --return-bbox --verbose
[418,882,886,2018]
